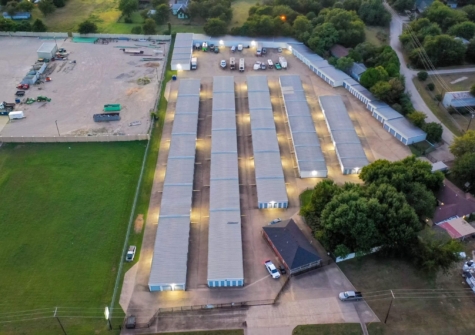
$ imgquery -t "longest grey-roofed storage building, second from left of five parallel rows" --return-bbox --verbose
[207,76,244,287]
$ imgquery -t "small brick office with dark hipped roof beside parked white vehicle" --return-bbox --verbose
[262,219,322,275]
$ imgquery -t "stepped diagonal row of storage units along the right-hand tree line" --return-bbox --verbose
[288,44,427,145]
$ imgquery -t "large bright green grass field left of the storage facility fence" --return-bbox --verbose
[0,142,145,334]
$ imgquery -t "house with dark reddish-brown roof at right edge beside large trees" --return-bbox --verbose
[432,179,475,224]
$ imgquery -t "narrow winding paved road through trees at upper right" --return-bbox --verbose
[384,3,458,143]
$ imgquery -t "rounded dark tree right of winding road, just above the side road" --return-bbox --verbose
[424,35,467,66]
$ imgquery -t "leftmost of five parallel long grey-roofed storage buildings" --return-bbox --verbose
[148,79,200,291]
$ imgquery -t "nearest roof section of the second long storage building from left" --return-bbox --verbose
[208,210,244,280]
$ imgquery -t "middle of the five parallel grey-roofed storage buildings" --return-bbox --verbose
[247,76,289,208]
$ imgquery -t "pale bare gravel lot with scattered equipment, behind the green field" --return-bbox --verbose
[0,37,168,137]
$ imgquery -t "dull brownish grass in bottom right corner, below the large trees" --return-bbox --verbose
[338,255,475,335]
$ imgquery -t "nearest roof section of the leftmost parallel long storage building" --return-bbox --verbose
[148,217,190,285]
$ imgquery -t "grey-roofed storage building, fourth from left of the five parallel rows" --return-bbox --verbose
[279,75,328,178]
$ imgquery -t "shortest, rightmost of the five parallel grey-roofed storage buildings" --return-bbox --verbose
[318,95,369,174]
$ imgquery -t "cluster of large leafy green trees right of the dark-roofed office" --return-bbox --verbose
[301,156,461,271]
